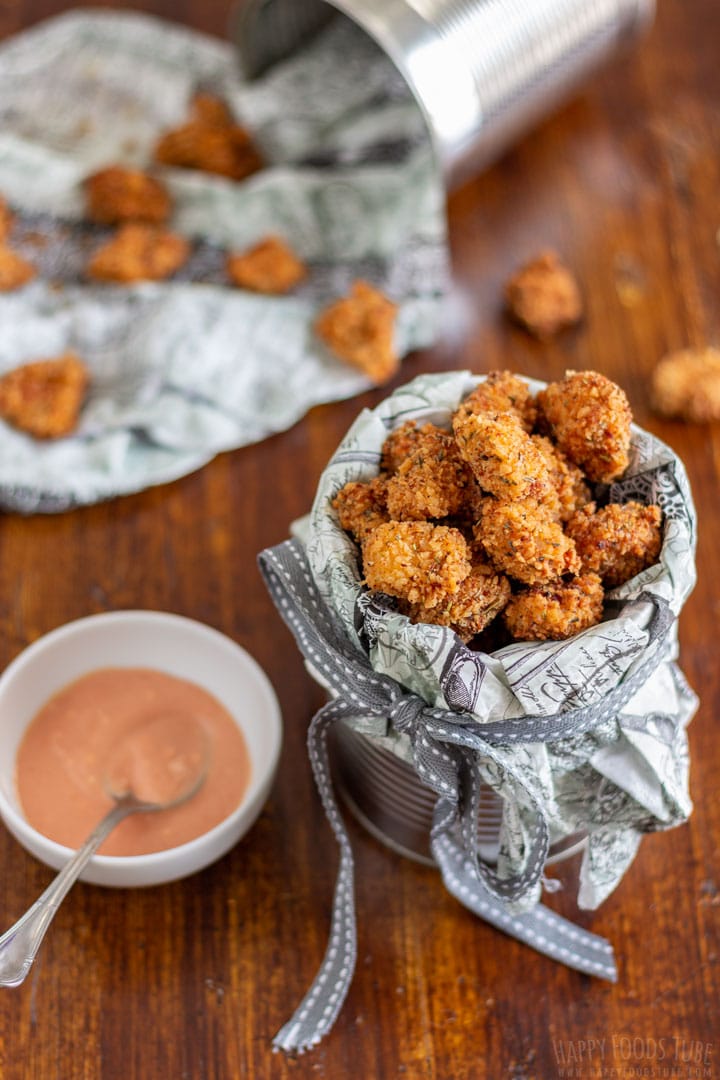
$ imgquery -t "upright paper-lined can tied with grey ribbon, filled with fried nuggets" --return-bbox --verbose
[260,372,697,1049]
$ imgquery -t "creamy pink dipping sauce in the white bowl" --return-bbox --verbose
[15,667,250,855]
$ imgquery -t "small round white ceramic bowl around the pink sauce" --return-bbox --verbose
[0,611,282,887]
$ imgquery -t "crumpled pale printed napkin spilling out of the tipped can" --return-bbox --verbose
[0,10,448,513]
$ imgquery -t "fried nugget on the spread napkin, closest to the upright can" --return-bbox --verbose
[315,281,400,384]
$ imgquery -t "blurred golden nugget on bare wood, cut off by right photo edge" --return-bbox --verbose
[651,348,720,423]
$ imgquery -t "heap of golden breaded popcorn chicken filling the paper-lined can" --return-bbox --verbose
[332,372,662,643]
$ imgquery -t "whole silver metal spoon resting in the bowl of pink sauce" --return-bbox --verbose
[0,714,209,986]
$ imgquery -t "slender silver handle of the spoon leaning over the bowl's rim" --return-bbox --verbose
[0,795,146,986]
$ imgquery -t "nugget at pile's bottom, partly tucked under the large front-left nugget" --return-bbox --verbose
[404,562,511,642]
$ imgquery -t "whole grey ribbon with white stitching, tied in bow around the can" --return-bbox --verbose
[258,540,674,1052]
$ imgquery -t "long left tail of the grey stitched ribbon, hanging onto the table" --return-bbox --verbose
[273,701,357,1053]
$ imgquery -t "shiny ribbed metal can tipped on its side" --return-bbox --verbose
[232,0,655,188]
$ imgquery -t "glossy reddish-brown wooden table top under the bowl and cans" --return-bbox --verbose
[0,0,720,1080]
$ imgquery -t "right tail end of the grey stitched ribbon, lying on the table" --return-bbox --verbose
[432,833,617,983]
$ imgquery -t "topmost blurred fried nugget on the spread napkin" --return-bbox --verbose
[153,94,263,180]
